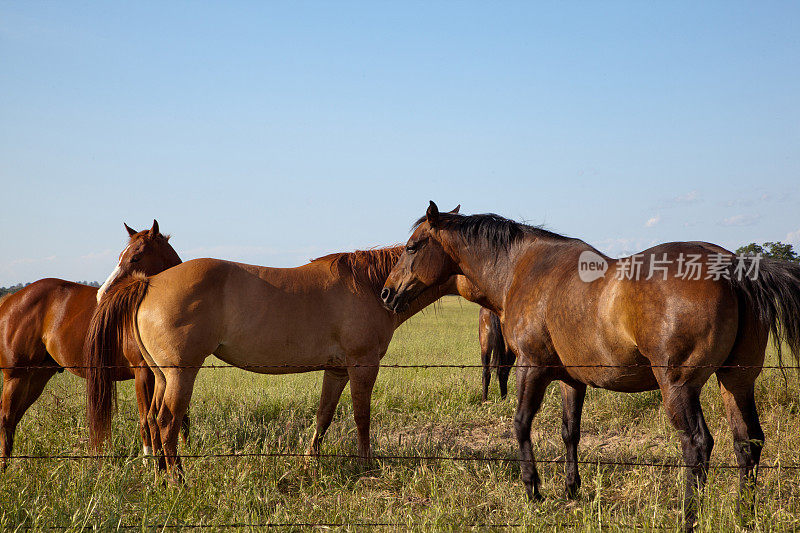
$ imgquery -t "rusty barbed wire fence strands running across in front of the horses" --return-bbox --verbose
[0,363,800,530]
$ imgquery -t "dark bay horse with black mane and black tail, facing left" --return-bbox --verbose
[381,202,800,530]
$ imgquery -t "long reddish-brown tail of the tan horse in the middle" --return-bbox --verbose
[84,274,149,450]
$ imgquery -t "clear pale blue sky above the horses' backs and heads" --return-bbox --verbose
[0,1,800,285]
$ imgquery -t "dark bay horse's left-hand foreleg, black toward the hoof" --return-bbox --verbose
[514,367,551,500]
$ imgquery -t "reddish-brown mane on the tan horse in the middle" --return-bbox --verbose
[311,245,403,294]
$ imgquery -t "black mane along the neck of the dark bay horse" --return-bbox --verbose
[412,213,570,248]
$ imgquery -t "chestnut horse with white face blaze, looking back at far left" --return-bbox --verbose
[0,220,181,469]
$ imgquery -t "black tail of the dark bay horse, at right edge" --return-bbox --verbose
[731,258,800,367]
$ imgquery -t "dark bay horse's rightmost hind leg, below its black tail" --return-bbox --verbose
[717,369,764,524]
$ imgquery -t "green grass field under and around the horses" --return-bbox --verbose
[0,298,800,531]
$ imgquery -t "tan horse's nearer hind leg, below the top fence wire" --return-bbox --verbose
[158,368,199,481]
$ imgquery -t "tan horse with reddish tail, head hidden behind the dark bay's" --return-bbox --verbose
[87,246,479,478]
